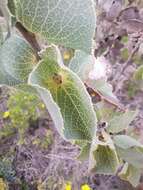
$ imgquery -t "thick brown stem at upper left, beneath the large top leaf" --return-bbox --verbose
[15,22,41,60]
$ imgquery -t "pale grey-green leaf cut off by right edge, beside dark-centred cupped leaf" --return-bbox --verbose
[114,135,143,168]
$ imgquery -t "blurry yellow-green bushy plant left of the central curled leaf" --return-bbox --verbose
[0,91,43,144]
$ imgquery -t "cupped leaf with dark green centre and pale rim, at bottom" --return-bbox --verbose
[89,133,119,174]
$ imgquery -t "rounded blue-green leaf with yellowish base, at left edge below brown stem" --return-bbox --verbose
[0,35,37,83]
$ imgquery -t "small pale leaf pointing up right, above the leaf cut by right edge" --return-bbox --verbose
[107,110,138,133]
